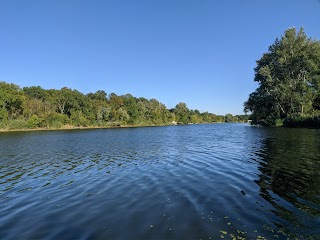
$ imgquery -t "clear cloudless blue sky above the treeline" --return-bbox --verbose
[0,0,320,114]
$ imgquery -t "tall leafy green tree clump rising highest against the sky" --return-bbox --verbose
[244,28,320,127]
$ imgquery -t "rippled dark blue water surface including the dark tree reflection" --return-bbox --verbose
[0,124,320,239]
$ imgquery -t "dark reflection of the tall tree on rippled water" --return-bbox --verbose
[255,129,320,234]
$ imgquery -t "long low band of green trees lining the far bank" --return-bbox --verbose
[0,82,248,130]
